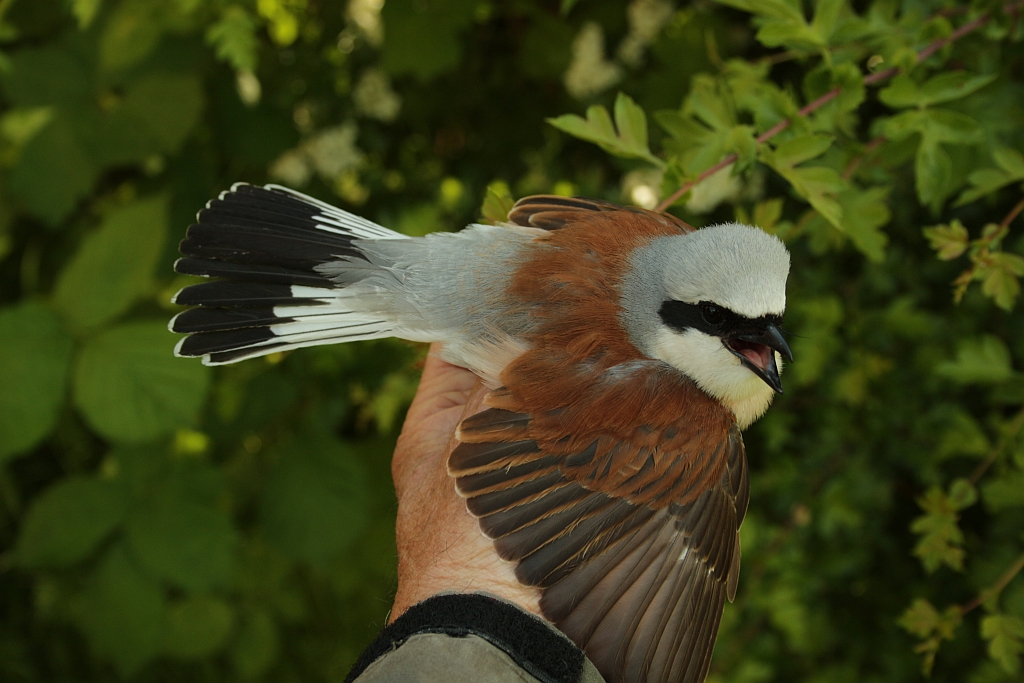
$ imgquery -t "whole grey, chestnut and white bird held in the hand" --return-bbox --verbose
[170,183,793,683]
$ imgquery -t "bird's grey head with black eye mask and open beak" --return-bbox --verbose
[622,223,793,428]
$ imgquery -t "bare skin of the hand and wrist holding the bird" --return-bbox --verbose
[389,344,541,622]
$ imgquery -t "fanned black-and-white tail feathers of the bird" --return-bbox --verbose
[170,183,407,366]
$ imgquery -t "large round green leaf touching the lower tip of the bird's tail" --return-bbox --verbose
[74,321,208,443]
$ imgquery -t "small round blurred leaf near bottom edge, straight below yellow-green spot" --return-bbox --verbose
[163,595,234,659]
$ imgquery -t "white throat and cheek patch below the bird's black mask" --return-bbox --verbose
[651,327,782,429]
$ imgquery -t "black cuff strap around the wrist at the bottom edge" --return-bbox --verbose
[345,593,586,683]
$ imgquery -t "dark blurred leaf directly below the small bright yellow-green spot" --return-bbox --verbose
[127,472,236,591]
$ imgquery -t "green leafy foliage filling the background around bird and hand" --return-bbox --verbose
[0,0,1024,683]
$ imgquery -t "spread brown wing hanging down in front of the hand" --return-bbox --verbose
[449,362,749,683]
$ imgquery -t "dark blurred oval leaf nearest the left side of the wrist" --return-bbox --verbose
[262,437,368,564]
